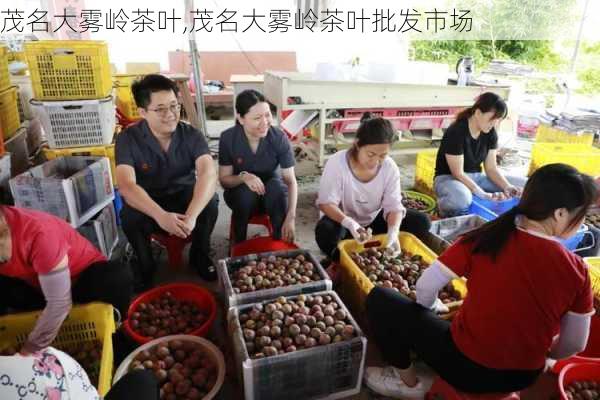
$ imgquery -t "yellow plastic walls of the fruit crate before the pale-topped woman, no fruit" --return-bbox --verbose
[337,232,467,315]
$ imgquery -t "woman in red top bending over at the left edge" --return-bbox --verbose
[0,206,133,354]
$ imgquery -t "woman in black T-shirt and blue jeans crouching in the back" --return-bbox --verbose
[433,92,525,217]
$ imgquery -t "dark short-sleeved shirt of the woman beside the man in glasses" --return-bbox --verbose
[219,125,295,181]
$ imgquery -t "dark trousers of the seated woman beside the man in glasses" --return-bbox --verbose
[223,176,288,243]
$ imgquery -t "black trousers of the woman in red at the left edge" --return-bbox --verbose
[0,261,133,317]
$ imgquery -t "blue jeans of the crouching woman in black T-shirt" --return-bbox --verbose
[433,172,527,217]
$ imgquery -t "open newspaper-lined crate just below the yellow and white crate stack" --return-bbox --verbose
[10,157,114,228]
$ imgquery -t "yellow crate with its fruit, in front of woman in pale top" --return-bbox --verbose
[338,232,467,315]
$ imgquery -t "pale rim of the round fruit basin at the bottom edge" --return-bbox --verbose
[113,335,225,400]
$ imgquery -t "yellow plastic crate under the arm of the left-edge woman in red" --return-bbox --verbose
[0,303,115,396]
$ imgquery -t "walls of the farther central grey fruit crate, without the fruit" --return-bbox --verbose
[217,249,333,308]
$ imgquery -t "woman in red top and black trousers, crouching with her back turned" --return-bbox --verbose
[365,164,598,398]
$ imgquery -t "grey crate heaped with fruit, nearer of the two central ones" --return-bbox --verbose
[228,291,367,400]
